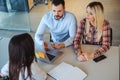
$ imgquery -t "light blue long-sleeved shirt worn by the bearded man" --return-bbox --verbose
[35,11,77,47]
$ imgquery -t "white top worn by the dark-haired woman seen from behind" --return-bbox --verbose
[1,61,47,80]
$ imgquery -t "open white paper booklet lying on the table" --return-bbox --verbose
[48,62,87,80]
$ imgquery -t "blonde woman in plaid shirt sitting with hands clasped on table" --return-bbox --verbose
[74,2,111,61]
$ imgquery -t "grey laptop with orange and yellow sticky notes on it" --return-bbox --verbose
[35,50,62,64]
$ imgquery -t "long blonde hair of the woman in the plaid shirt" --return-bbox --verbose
[86,2,104,41]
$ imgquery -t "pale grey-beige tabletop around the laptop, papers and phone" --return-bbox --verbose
[39,45,120,80]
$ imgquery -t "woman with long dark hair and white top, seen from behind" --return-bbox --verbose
[1,33,46,80]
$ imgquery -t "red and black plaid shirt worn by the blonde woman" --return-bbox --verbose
[74,18,111,57]
